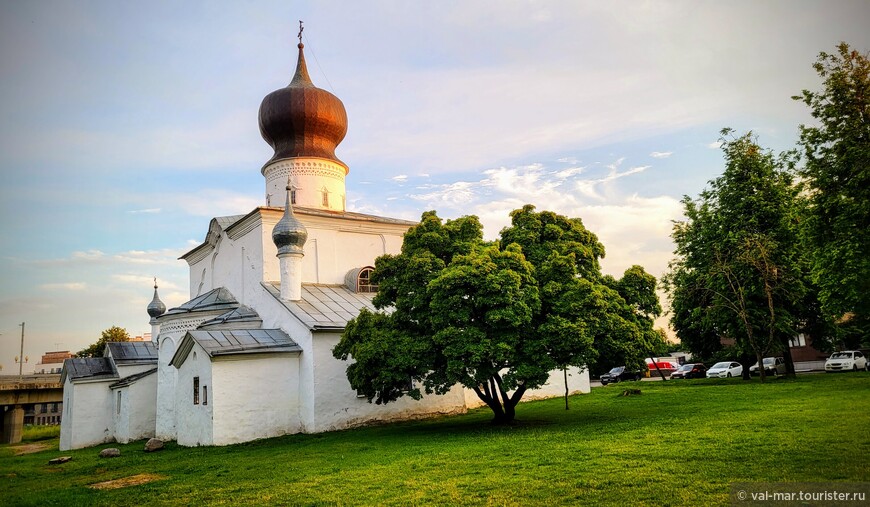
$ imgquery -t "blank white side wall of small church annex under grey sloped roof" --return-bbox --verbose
[209,353,302,445]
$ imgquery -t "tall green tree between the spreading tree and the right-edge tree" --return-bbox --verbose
[664,129,806,378]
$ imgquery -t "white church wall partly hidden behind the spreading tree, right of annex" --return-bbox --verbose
[310,333,466,433]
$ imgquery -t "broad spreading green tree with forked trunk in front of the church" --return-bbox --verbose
[333,206,655,422]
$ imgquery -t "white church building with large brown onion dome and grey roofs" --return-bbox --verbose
[60,35,589,450]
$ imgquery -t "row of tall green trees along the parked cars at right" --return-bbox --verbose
[663,43,870,378]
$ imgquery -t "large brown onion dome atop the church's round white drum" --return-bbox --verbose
[260,43,347,168]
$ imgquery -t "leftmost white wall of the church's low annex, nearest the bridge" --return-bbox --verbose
[59,379,116,451]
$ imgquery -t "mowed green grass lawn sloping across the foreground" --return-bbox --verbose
[0,372,870,506]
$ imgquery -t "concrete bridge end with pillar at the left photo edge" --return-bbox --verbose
[0,374,63,444]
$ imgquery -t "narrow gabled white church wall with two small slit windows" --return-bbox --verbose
[175,343,214,447]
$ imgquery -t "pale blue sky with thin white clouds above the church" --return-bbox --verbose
[0,0,870,374]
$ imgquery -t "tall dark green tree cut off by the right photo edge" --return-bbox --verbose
[794,43,870,343]
